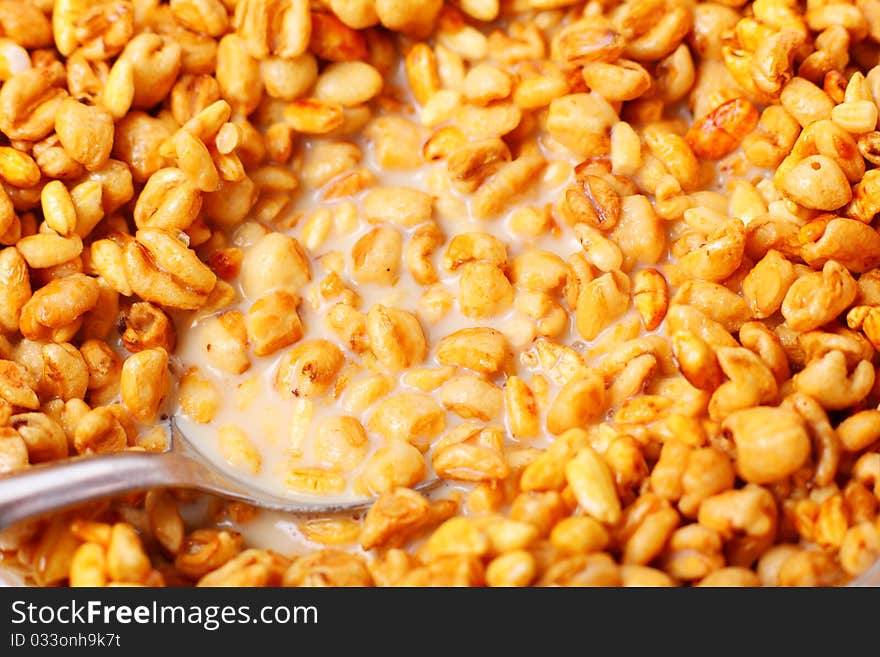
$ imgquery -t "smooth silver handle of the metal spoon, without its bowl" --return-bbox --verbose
[0,452,190,530]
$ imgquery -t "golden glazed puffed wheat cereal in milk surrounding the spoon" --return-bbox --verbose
[0,0,880,586]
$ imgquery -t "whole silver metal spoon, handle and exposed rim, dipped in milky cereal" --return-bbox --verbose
[0,419,439,530]
